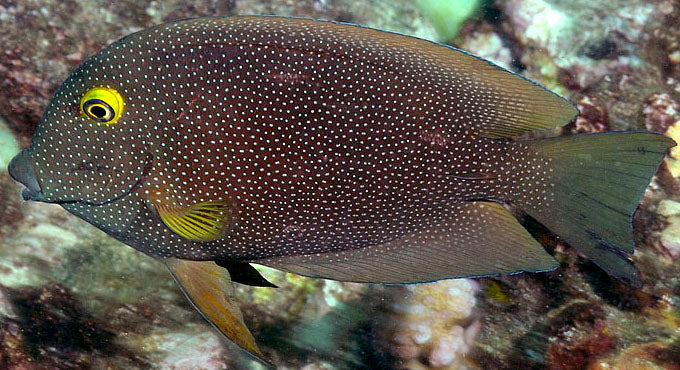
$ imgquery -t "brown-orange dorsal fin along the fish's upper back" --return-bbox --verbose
[232,17,578,138]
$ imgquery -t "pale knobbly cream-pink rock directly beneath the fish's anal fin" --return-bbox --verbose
[373,279,479,369]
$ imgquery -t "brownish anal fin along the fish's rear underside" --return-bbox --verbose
[252,201,558,284]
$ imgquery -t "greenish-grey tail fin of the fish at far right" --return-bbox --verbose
[525,132,675,287]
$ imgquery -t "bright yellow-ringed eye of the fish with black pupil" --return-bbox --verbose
[80,87,125,125]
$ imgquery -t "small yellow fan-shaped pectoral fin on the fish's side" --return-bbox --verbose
[154,200,233,242]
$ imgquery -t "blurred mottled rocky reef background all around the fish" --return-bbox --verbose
[0,0,680,370]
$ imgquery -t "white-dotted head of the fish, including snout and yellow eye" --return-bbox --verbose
[9,41,153,205]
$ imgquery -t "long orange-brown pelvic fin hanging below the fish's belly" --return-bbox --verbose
[163,258,268,363]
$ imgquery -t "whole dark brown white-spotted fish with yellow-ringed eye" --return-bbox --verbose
[9,16,675,357]
